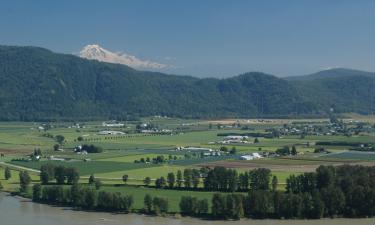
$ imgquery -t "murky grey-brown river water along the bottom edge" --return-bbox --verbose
[0,193,375,225]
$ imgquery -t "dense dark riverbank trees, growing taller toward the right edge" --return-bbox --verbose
[212,165,375,219]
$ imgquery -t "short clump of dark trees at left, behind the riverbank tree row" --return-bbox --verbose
[40,163,79,184]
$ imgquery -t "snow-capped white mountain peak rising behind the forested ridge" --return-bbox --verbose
[78,44,168,70]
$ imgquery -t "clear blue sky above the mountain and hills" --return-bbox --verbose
[0,0,375,77]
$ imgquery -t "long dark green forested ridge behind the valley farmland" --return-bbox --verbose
[0,46,375,121]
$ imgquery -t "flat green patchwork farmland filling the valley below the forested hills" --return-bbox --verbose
[0,117,375,206]
